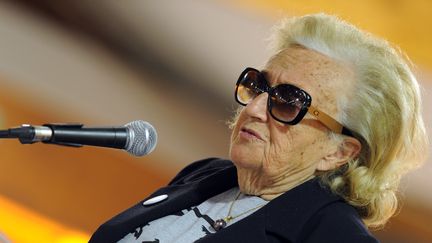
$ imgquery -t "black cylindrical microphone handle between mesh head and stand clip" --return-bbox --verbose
[42,124,129,149]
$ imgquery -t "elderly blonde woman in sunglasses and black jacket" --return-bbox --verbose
[90,14,427,242]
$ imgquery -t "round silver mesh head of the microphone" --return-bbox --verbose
[125,120,157,156]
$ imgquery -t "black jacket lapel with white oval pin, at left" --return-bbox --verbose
[89,161,237,243]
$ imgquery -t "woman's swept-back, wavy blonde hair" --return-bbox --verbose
[272,14,427,228]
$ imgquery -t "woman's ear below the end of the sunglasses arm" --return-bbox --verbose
[317,137,361,171]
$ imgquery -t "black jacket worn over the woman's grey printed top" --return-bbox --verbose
[90,159,377,243]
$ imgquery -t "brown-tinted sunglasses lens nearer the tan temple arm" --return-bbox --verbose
[270,84,307,122]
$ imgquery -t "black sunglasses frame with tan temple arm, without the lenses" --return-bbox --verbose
[234,67,353,137]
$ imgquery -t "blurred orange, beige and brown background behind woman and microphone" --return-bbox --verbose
[0,0,432,243]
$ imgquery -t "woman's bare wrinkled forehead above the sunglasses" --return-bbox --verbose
[263,46,354,104]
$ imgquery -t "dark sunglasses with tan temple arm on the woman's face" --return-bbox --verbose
[235,68,353,136]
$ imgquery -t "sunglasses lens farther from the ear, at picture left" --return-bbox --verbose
[236,70,267,105]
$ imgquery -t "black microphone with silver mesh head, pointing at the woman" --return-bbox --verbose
[0,120,157,156]
